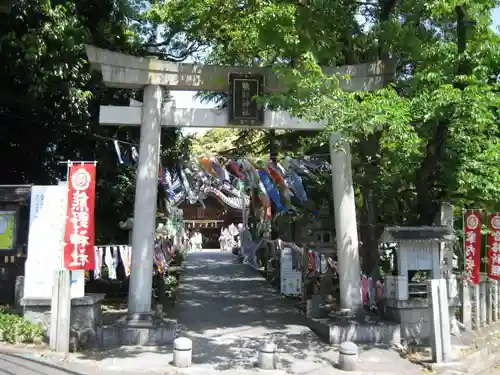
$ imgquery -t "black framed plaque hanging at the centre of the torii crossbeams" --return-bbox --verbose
[229,73,264,126]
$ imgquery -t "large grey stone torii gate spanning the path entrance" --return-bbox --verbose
[86,45,395,321]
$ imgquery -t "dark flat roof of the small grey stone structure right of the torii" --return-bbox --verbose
[380,226,455,243]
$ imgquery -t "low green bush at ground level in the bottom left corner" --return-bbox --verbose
[0,307,44,344]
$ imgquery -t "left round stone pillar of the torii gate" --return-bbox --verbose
[128,85,162,317]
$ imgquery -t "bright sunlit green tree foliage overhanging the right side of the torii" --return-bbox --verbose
[154,0,500,271]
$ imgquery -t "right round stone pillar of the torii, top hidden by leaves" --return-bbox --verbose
[330,133,362,310]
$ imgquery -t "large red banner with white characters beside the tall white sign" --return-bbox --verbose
[64,163,96,271]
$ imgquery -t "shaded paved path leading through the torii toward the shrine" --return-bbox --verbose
[173,251,421,375]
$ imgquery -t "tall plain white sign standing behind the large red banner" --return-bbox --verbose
[24,183,84,298]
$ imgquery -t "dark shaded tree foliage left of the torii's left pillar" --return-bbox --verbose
[0,0,184,243]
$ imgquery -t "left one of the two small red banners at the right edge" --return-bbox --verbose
[464,211,482,285]
